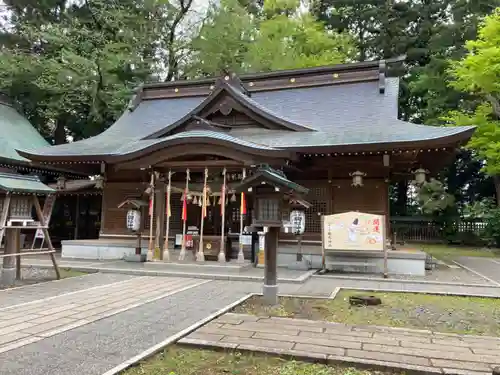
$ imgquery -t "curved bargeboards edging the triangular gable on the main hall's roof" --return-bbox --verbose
[142,81,316,140]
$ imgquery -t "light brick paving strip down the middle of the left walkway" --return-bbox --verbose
[0,277,208,353]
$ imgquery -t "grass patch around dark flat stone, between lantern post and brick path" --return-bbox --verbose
[234,290,500,336]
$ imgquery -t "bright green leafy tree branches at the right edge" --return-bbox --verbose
[445,9,500,204]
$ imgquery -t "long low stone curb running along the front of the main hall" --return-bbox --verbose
[26,264,316,284]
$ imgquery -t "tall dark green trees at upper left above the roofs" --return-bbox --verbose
[0,0,192,144]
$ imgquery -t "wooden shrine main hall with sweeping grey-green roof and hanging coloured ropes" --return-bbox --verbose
[18,59,474,270]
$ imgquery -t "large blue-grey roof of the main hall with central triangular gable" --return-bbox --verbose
[15,61,474,161]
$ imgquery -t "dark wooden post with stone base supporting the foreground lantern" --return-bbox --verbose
[263,227,279,305]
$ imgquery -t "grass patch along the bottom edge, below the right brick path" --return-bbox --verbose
[124,346,403,375]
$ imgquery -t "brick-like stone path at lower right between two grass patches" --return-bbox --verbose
[179,313,500,375]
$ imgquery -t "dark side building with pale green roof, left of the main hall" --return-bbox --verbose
[0,93,102,246]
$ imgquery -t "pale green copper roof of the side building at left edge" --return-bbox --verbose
[0,97,49,162]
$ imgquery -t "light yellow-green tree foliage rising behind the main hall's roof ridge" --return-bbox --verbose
[188,0,354,75]
